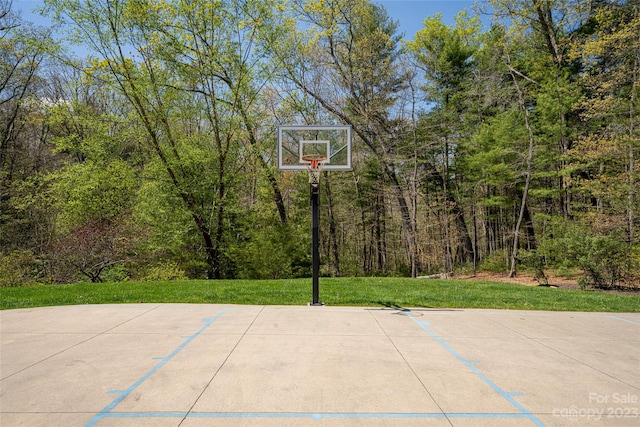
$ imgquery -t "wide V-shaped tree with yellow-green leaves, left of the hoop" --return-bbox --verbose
[47,0,286,278]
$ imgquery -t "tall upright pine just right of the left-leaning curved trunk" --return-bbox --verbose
[408,12,480,271]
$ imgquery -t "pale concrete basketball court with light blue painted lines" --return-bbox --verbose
[0,304,640,427]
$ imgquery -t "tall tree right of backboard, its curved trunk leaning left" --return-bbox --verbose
[267,0,419,276]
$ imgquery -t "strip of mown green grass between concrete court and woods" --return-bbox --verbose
[0,277,640,312]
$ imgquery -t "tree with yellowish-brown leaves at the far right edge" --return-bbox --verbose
[569,1,640,288]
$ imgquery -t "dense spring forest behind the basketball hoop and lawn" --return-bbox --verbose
[0,0,640,288]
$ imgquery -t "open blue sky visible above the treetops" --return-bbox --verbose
[13,0,474,39]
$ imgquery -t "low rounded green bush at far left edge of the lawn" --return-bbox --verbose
[0,250,43,288]
